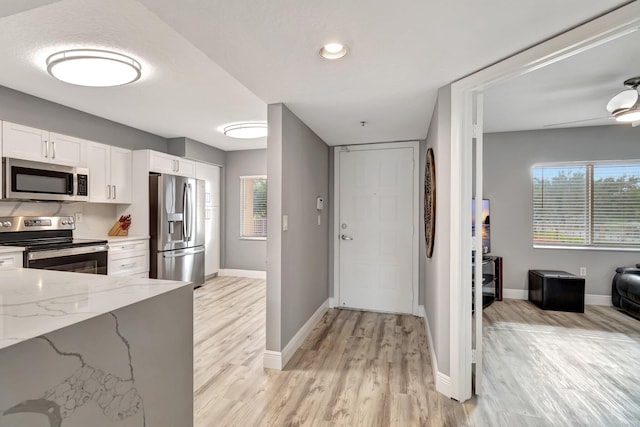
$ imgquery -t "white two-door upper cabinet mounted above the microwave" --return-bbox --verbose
[2,122,88,166]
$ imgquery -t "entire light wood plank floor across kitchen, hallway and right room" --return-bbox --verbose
[194,277,640,427]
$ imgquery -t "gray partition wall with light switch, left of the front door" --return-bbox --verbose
[267,104,329,351]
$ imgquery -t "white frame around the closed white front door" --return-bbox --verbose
[330,141,420,316]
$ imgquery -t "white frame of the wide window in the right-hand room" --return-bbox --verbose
[529,159,640,252]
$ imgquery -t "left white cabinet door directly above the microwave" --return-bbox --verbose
[2,122,49,162]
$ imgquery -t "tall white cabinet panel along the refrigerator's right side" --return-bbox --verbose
[196,162,220,277]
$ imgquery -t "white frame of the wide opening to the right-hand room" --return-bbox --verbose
[449,1,640,402]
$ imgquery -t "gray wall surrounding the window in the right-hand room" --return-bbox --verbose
[483,126,640,295]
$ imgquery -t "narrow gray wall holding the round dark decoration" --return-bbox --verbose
[420,86,451,375]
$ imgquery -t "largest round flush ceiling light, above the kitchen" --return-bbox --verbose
[47,49,142,87]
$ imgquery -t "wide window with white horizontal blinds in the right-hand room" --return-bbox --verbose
[533,162,640,248]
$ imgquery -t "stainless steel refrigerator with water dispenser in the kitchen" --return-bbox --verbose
[149,174,205,288]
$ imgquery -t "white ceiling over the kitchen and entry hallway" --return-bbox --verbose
[0,0,625,150]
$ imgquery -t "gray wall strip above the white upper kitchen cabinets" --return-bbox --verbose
[0,86,167,152]
